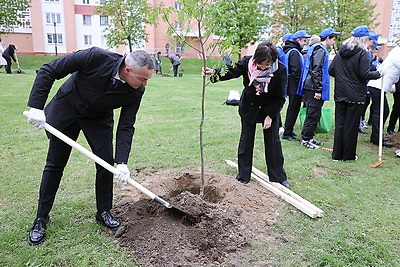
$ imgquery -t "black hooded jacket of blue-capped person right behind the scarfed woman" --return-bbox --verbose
[283,40,303,95]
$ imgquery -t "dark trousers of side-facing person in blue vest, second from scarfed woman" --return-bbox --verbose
[301,90,324,140]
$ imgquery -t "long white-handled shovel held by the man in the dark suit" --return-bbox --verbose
[23,111,196,223]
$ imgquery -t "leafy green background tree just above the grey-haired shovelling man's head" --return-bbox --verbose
[96,0,153,52]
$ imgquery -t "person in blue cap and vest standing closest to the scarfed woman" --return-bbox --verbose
[282,30,311,141]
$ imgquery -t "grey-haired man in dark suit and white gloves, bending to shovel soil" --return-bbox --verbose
[24,47,154,245]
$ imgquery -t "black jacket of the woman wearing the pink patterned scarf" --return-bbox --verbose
[211,56,287,123]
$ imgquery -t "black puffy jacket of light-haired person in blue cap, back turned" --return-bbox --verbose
[329,45,380,103]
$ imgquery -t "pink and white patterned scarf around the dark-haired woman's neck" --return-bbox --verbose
[248,57,278,95]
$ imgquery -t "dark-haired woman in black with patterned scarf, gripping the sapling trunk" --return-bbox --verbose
[203,41,289,187]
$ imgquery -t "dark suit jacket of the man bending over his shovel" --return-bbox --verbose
[28,47,145,162]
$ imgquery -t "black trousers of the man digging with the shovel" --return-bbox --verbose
[37,122,113,218]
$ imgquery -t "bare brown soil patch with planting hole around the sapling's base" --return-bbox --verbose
[110,172,283,266]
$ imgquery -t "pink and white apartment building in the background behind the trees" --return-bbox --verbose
[1,0,400,58]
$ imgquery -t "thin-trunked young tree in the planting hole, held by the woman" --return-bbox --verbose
[158,0,268,197]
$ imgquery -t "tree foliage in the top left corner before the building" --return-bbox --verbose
[0,0,30,33]
